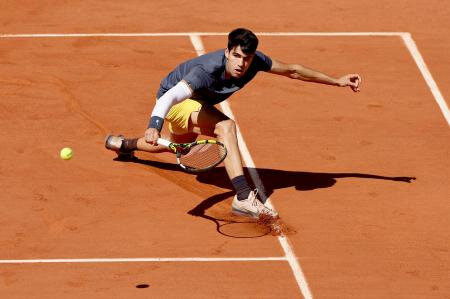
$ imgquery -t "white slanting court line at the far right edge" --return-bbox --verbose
[402,33,450,126]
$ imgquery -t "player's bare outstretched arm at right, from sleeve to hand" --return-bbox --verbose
[269,60,361,92]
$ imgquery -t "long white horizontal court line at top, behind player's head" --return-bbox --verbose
[0,32,407,38]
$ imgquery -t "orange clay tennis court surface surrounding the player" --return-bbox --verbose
[0,0,450,299]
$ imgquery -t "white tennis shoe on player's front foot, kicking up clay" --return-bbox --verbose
[231,189,278,219]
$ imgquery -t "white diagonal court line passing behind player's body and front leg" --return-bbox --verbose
[189,34,313,299]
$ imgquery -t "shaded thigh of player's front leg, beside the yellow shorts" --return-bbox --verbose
[189,105,229,136]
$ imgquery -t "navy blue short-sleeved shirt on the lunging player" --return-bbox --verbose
[156,49,272,105]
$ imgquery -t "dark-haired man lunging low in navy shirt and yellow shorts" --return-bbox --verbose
[105,28,361,218]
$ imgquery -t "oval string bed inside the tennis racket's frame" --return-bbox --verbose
[180,143,226,169]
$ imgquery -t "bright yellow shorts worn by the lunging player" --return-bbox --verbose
[166,99,202,135]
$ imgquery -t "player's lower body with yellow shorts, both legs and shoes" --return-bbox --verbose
[105,100,277,218]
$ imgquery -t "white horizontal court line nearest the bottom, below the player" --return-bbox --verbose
[0,257,286,264]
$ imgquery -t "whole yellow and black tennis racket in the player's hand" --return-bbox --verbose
[157,138,227,173]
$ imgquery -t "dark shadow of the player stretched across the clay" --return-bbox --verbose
[122,158,416,238]
